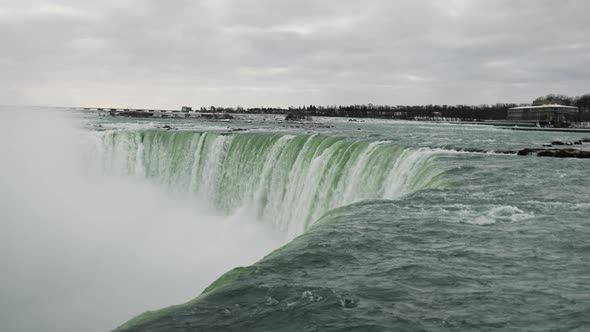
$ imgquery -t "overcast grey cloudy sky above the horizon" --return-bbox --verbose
[0,0,590,108]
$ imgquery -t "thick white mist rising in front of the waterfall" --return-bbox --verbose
[0,109,282,332]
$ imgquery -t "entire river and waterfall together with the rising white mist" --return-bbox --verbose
[0,109,590,331]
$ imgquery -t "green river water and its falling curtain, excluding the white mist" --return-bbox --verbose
[90,117,590,331]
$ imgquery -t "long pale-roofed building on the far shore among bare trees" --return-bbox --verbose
[508,104,580,124]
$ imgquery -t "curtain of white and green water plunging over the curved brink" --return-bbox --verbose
[95,131,440,240]
